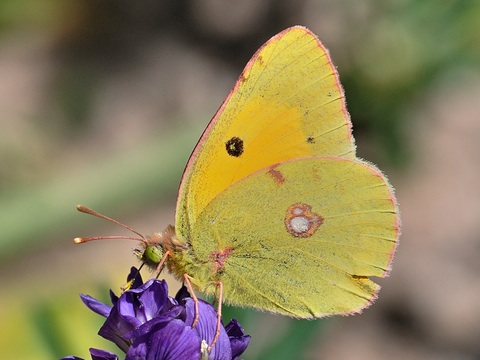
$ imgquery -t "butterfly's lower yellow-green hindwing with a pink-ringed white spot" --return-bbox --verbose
[187,157,399,318]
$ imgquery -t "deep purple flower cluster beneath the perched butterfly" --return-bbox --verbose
[64,268,250,360]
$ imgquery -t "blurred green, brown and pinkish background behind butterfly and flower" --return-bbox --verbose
[0,0,480,359]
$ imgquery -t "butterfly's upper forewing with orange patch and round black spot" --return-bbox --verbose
[175,26,355,235]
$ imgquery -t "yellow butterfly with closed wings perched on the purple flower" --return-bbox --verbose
[76,26,400,318]
